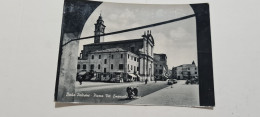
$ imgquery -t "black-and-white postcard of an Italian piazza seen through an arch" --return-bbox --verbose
[54,0,215,107]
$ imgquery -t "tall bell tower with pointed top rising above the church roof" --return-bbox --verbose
[94,14,106,43]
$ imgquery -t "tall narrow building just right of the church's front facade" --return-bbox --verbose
[154,54,168,80]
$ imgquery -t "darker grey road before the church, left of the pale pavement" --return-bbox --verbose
[74,81,169,104]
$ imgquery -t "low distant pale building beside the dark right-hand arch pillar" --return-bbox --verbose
[172,61,198,80]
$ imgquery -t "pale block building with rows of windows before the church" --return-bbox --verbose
[77,48,140,81]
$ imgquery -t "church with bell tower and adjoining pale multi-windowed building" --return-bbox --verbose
[78,16,154,81]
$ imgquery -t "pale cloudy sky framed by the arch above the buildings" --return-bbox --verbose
[78,3,197,69]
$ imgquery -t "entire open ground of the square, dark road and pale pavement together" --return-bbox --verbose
[74,80,199,106]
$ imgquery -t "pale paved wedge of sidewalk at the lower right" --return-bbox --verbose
[128,81,199,106]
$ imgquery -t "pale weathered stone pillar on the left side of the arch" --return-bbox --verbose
[56,33,79,102]
